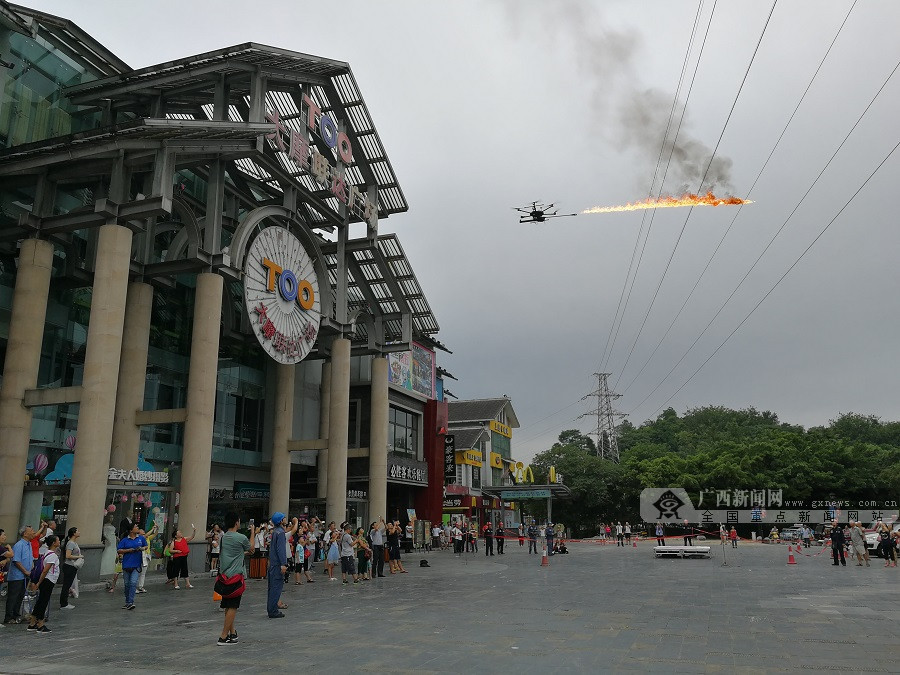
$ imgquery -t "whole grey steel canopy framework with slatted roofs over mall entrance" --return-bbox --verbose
[0,3,430,355]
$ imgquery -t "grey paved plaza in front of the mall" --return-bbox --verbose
[0,541,900,674]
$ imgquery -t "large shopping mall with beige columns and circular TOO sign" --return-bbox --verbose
[0,0,464,577]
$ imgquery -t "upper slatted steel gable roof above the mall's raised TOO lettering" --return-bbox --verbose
[58,42,408,226]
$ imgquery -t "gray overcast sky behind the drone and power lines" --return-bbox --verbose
[25,0,900,459]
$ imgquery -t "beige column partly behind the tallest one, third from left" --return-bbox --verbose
[109,282,153,472]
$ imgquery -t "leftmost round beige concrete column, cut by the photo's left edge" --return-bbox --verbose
[0,239,53,539]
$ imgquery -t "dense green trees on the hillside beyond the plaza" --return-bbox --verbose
[532,406,900,534]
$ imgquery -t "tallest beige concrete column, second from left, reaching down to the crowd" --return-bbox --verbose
[68,224,131,546]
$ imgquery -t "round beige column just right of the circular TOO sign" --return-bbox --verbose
[325,338,350,524]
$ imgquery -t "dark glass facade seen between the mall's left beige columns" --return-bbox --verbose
[0,260,267,478]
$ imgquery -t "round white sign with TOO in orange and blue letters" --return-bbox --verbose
[244,227,322,365]
